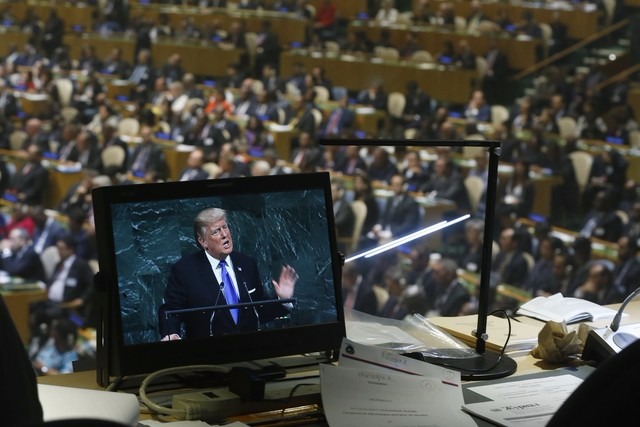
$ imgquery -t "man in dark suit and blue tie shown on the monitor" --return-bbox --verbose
[159,208,298,340]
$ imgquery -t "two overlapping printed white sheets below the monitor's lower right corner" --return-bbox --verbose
[320,339,476,427]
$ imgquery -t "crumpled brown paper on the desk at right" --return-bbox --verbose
[531,321,591,363]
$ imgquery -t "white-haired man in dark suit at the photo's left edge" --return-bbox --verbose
[0,227,45,281]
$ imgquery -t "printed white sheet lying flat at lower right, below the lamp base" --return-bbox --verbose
[462,374,582,427]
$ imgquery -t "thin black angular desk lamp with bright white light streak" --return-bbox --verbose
[320,139,517,380]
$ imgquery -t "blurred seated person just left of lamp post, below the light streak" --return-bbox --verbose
[426,258,475,317]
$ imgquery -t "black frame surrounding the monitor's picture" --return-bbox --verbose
[92,172,346,387]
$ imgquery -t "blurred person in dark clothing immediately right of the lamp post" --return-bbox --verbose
[491,228,529,287]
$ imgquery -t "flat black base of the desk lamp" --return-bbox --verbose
[405,352,518,381]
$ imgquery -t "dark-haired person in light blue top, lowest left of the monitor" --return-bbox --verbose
[30,317,79,376]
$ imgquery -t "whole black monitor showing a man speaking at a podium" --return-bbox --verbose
[92,173,345,385]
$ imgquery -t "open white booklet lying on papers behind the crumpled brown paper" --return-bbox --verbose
[517,293,616,324]
